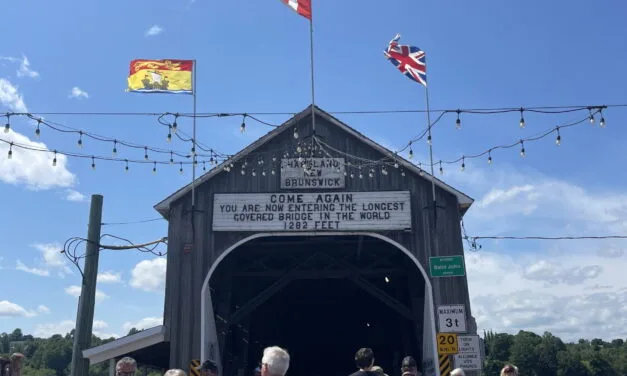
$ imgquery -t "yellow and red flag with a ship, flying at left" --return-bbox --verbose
[127,60,194,94]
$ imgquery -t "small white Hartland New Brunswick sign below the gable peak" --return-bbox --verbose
[281,158,346,189]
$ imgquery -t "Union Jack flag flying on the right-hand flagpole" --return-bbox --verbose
[383,34,427,87]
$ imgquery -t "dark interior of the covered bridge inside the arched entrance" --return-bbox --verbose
[210,236,424,376]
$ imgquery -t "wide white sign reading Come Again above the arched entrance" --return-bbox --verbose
[213,191,411,231]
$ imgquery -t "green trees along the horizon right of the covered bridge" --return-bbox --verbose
[483,330,627,376]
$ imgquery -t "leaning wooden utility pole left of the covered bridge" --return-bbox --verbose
[70,195,103,376]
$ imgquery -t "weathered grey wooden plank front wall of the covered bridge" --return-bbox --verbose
[164,112,470,368]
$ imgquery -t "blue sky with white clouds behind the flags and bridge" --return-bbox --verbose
[0,0,627,339]
